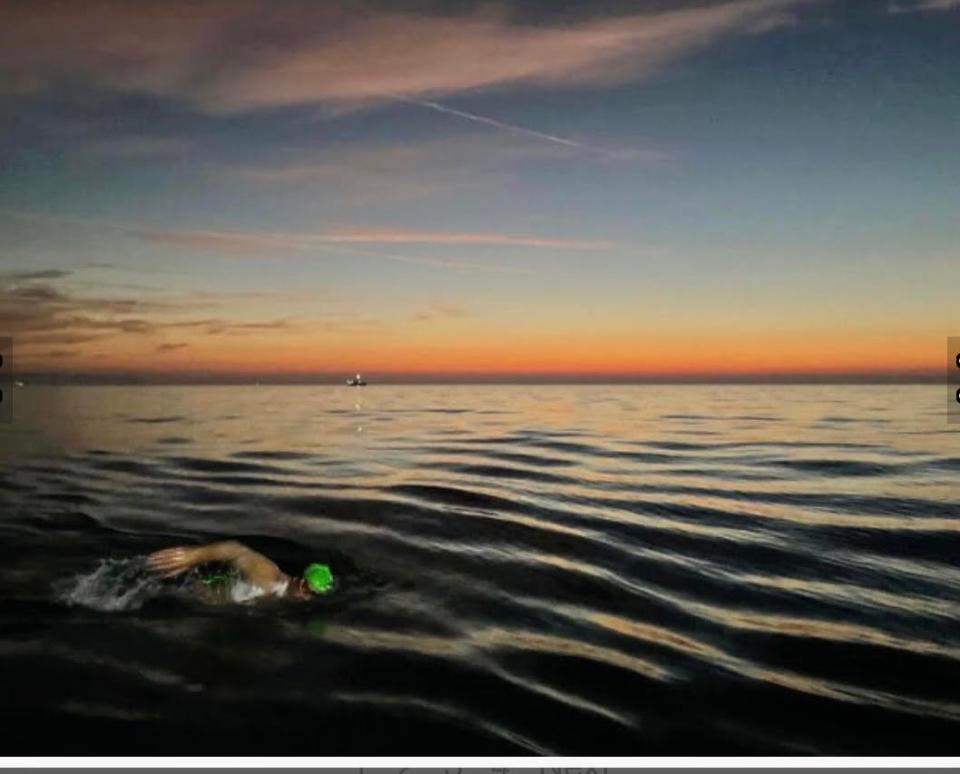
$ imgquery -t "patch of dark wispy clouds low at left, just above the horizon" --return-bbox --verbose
[0,270,388,372]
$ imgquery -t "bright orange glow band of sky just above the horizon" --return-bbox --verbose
[18,324,943,377]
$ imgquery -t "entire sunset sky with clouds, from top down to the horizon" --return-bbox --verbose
[0,0,960,379]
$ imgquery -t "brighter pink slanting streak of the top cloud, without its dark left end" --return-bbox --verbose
[195,0,792,111]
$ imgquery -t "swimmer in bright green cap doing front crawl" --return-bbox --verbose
[147,540,333,601]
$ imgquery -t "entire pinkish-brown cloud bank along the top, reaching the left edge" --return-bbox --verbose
[0,0,790,115]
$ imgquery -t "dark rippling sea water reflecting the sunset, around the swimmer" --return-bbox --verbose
[0,385,960,755]
